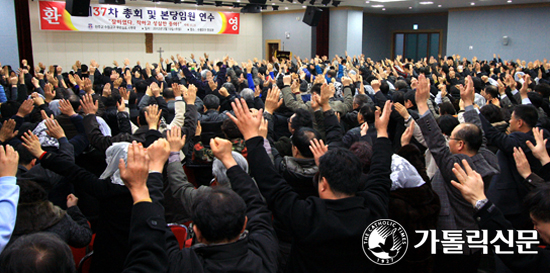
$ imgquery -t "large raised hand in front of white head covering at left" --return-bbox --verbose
[118,141,151,204]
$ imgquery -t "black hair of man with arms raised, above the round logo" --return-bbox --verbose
[319,148,363,195]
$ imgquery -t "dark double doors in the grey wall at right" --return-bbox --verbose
[392,30,442,61]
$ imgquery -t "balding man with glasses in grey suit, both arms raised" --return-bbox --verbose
[416,75,499,272]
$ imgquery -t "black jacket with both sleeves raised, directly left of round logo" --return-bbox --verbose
[246,137,392,272]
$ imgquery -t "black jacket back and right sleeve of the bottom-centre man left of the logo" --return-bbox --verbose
[166,160,278,273]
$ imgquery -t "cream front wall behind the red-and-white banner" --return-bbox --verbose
[29,0,263,70]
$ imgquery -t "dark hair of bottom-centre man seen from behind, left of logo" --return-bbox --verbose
[191,187,246,243]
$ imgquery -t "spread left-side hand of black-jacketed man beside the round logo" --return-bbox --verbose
[227,98,263,141]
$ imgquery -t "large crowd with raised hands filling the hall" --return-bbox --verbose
[0,52,550,272]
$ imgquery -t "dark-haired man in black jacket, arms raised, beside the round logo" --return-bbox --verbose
[226,96,391,272]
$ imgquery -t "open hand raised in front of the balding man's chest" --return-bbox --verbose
[451,159,487,207]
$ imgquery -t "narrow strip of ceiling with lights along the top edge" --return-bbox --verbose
[130,0,550,14]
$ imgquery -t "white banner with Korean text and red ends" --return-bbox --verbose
[40,1,240,34]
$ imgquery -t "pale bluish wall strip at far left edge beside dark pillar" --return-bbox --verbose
[0,0,20,67]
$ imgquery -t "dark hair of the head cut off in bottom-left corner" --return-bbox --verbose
[0,232,76,273]
